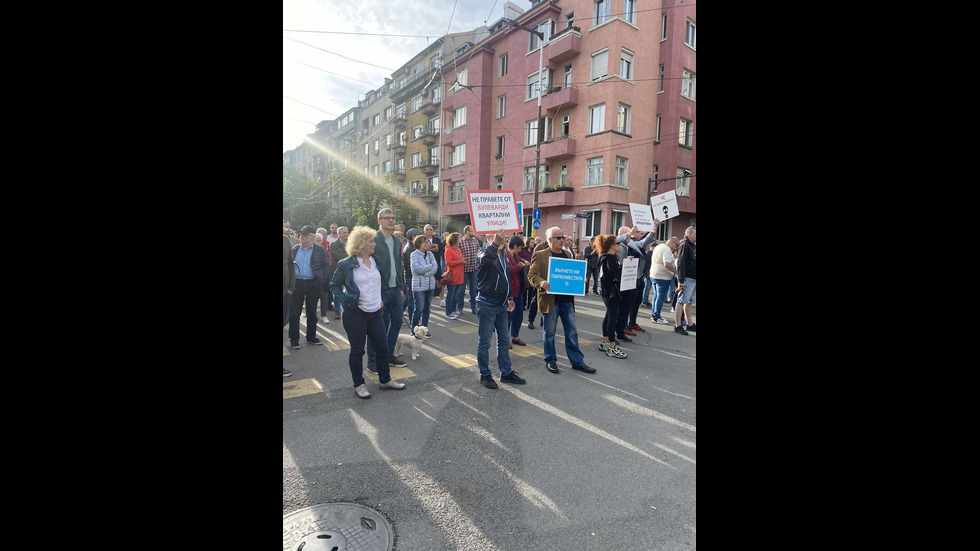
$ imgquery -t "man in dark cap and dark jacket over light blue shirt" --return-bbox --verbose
[289,224,330,348]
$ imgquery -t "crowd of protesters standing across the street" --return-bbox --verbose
[283,215,697,398]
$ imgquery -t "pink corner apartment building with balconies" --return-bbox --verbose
[440,0,696,248]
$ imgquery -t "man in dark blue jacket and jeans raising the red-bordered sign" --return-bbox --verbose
[476,230,527,388]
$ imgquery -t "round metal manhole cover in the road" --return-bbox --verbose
[282,503,395,551]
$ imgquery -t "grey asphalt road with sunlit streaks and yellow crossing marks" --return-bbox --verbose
[282,295,697,551]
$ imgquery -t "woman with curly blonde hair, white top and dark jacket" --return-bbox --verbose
[330,226,405,398]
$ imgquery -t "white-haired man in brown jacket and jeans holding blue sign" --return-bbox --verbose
[527,226,596,373]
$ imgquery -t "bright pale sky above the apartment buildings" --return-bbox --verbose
[282,0,531,152]
